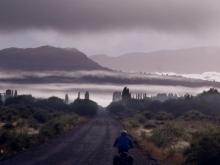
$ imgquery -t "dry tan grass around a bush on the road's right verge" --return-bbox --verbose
[121,118,220,165]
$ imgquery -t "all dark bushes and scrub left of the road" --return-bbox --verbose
[0,96,98,160]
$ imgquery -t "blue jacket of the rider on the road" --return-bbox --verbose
[113,135,133,152]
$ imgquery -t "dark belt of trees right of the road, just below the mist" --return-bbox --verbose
[120,88,220,116]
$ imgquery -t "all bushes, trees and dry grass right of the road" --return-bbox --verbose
[107,89,220,165]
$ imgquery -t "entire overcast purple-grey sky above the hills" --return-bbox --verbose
[0,0,220,56]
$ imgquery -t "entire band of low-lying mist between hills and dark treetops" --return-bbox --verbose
[0,71,220,106]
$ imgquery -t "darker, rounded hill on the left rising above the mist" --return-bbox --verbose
[0,46,107,71]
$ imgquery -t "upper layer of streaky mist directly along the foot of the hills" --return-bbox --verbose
[0,70,220,87]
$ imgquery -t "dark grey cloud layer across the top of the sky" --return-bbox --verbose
[0,0,220,32]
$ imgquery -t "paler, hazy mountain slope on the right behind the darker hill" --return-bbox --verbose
[90,47,220,73]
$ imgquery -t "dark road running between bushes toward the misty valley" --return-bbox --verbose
[0,111,158,165]
